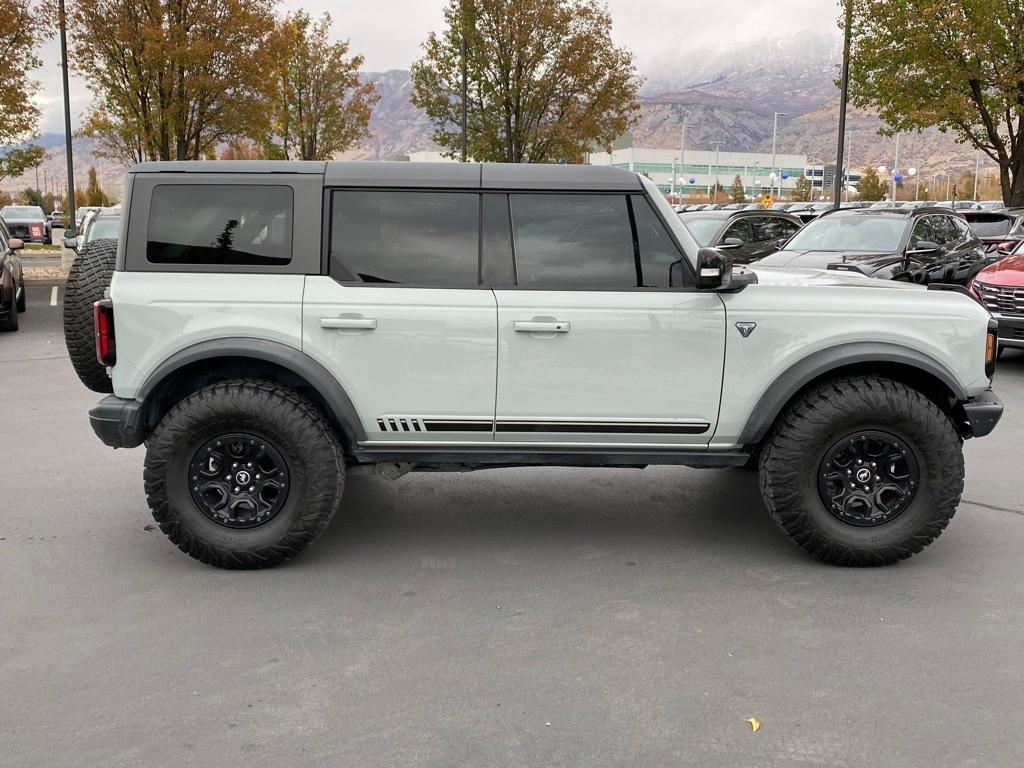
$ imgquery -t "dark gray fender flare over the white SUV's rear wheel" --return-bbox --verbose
[135,337,367,449]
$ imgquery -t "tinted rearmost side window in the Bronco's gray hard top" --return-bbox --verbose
[145,184,294,265]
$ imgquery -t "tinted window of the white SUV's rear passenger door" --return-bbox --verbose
[331,189,480,288]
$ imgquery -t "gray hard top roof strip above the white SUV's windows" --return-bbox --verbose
[128,160,643,191]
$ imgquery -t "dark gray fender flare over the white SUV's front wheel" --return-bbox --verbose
[738,341,968,445]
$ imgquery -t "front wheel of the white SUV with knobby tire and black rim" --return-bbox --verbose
[760,377,964,565]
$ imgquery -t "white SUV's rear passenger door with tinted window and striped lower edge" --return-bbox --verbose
[302,188,497,443]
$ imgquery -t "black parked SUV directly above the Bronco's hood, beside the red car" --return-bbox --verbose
[758,208,988,284]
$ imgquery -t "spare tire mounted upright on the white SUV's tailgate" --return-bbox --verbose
[63,239,118,392]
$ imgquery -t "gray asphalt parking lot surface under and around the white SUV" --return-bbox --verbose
[0,287,1024,768]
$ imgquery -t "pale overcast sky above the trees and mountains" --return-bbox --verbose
[35,0,839,133]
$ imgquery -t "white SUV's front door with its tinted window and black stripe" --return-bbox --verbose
[495,194,725,447]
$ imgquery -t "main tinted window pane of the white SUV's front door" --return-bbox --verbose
[509,194,638,290]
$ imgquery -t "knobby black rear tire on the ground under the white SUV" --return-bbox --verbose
[143,380,345,569]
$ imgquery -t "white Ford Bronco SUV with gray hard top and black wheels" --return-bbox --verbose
[78,162,1002,568]
